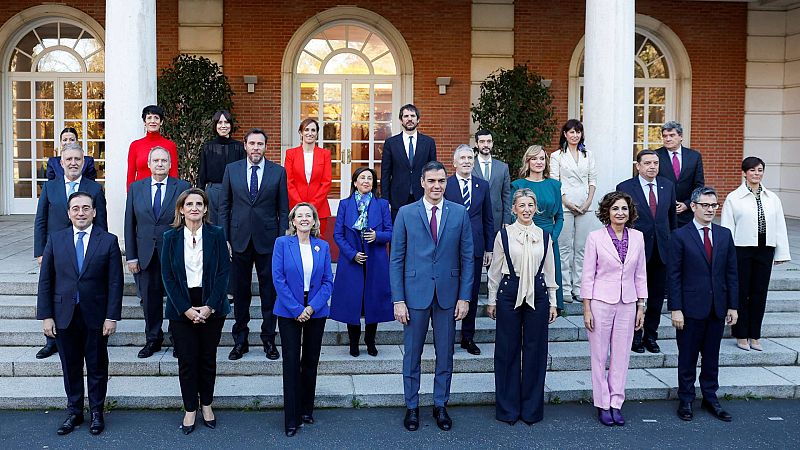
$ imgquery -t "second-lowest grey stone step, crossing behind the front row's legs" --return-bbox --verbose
[0,338,800,377]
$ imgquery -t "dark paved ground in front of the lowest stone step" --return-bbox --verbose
[0,400,800,449]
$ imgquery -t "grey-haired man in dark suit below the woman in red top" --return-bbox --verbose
[125,147,190,358]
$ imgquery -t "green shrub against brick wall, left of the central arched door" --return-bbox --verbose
[158,54,234,185]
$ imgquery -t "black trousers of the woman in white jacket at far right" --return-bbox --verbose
[731,239,775,339]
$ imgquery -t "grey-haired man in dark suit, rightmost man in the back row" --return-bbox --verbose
[656,121,705,227]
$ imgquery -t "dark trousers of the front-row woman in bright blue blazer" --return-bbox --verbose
[278,317,327,428]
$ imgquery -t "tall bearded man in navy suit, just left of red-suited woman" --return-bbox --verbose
[219,128,289,360]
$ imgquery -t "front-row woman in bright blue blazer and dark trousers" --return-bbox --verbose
[272,202,333,437]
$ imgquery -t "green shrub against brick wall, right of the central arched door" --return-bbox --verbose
[471,64,556,178]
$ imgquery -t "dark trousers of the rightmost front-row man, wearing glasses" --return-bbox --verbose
[675,312,725,403]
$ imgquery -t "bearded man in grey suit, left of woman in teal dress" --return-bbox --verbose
[472,130,511,237]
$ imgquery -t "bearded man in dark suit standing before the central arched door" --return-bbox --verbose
[381,104,436,220]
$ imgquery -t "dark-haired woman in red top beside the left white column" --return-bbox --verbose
[127,105,178,188]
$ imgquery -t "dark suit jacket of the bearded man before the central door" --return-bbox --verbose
[381,132,436,210]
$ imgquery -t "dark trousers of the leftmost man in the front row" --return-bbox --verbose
[56,305,108,415]
